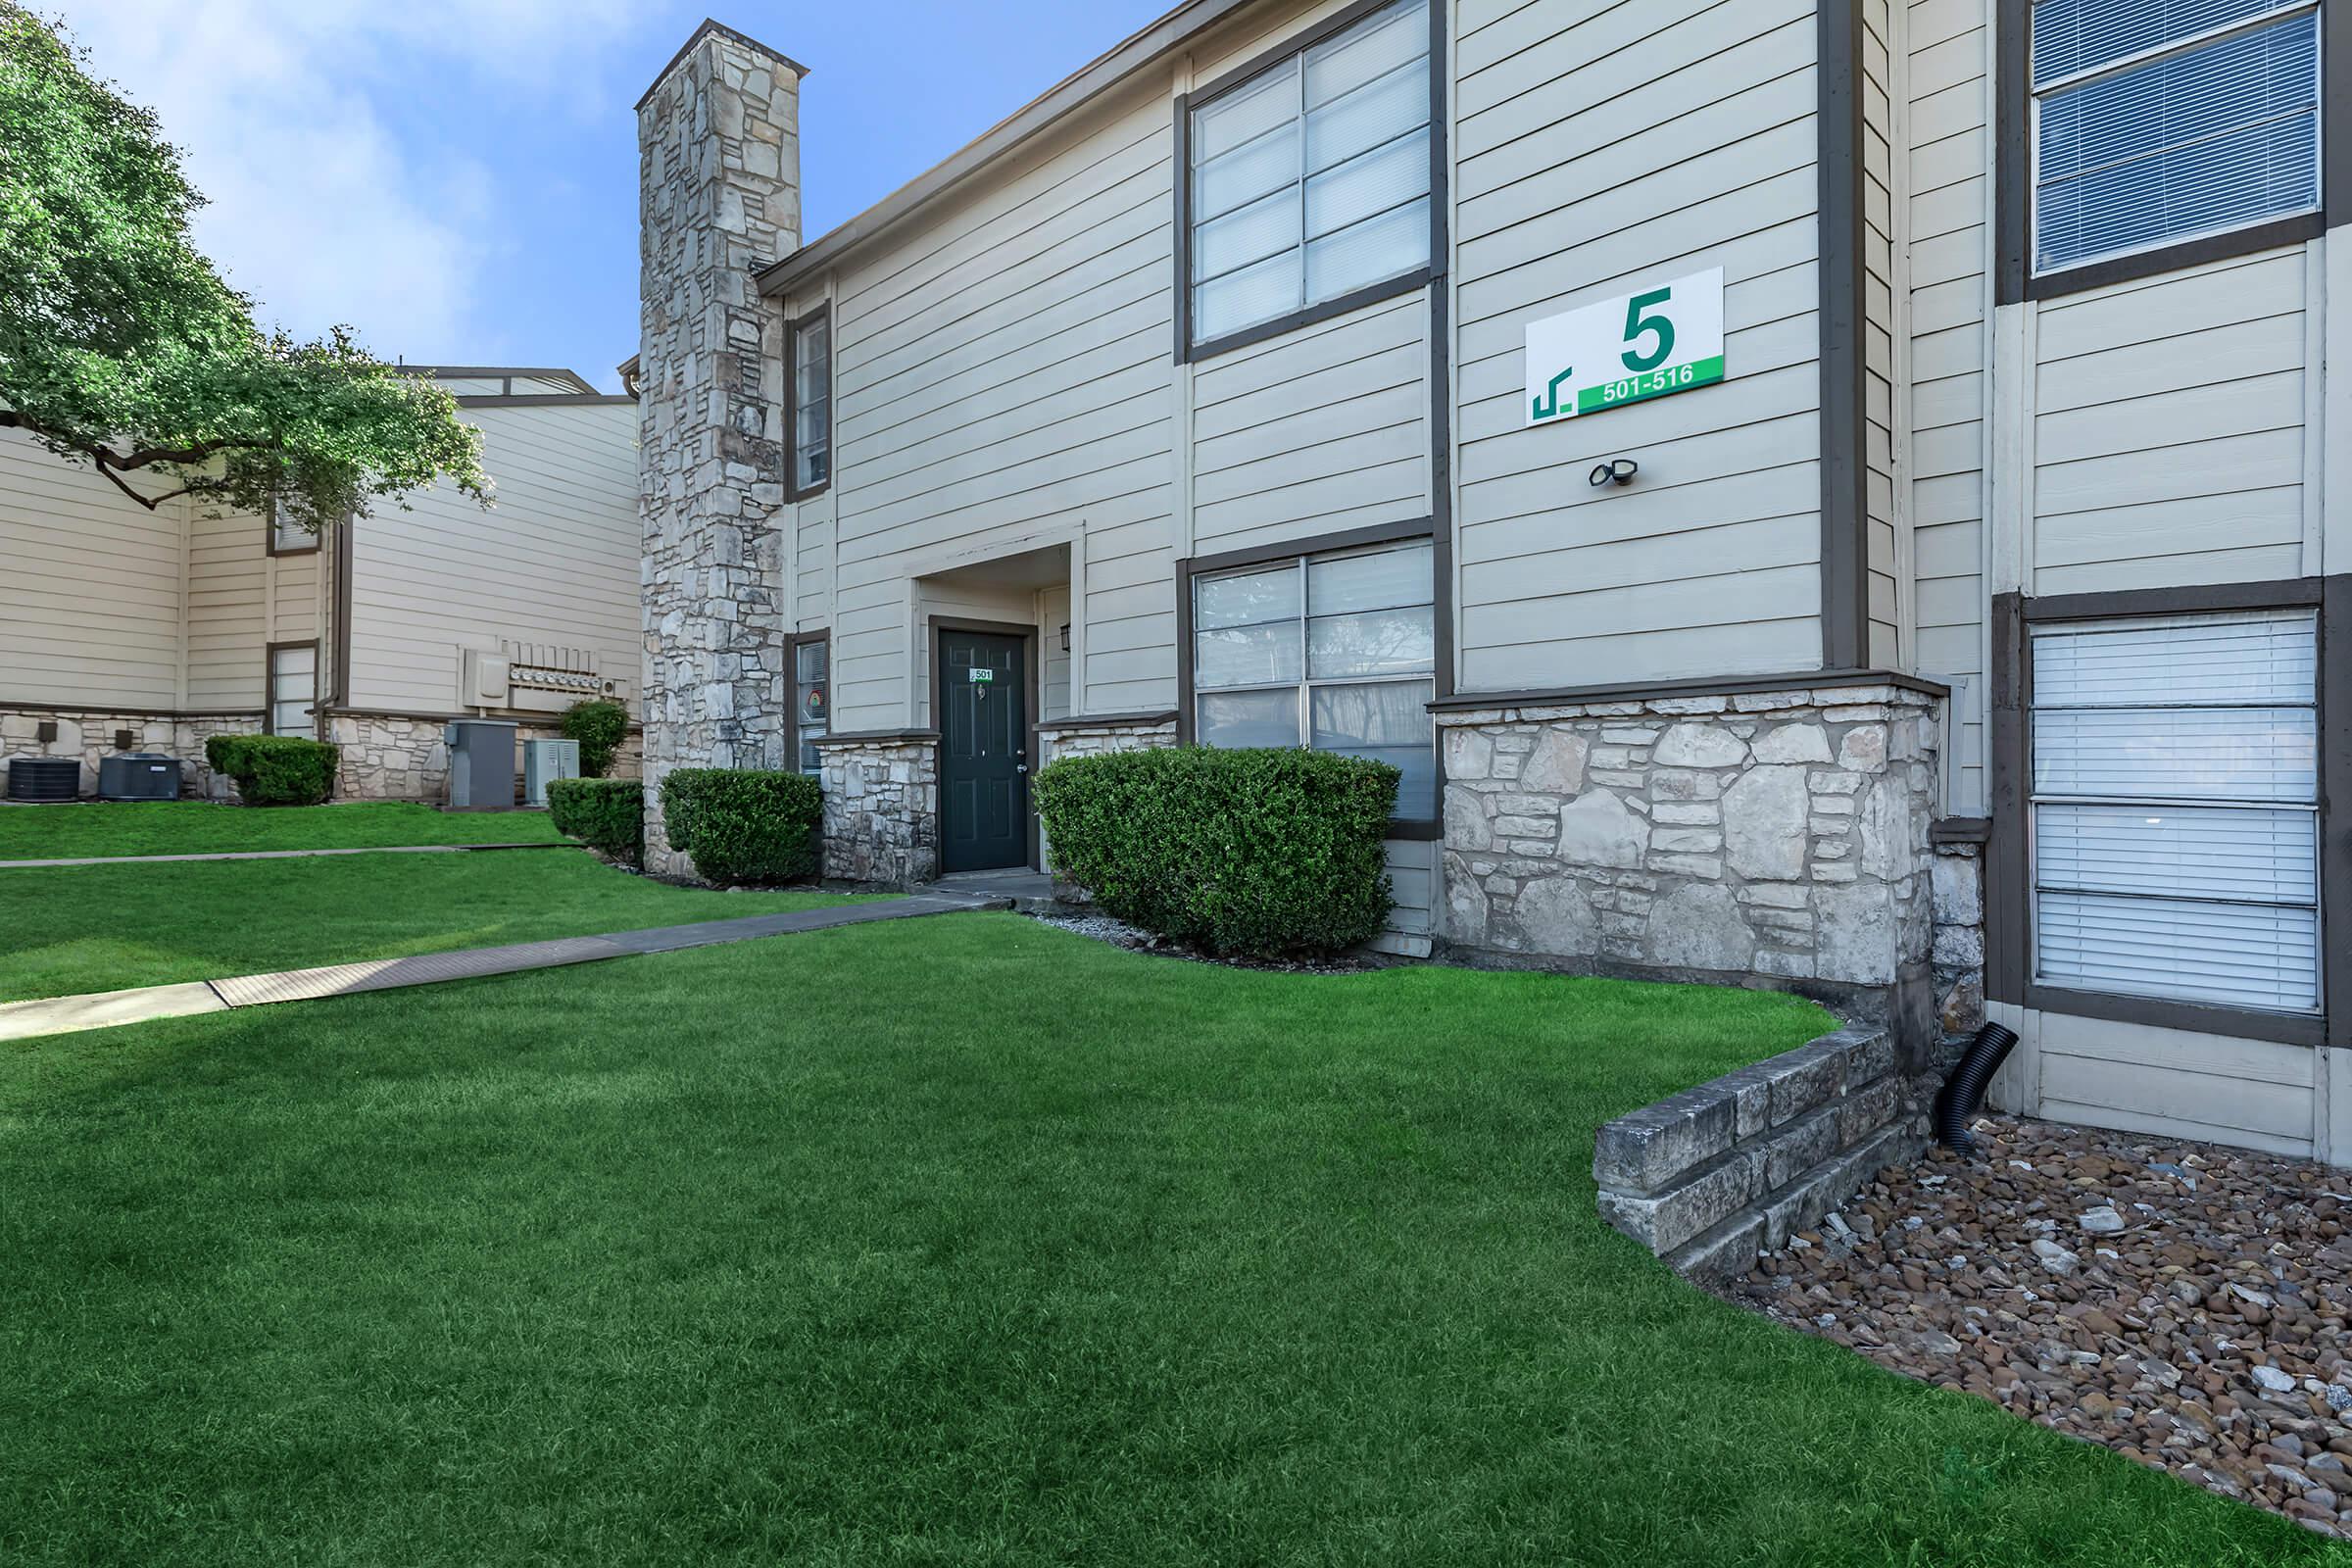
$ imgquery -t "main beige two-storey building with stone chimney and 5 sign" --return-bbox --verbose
[637,0,2352,1161]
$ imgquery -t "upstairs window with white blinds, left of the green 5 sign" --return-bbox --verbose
[1183,0,1435,348]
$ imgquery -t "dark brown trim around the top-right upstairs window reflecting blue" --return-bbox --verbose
[1994,0,2352,306]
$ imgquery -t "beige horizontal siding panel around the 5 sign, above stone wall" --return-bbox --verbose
[1453,0,1821,691]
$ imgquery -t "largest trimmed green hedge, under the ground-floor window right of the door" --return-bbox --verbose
[1037,745,1399,959]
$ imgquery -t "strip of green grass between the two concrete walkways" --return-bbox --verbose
[0,849,874,1002]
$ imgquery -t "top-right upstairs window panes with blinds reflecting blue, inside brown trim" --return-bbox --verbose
[2033,0,2322,272]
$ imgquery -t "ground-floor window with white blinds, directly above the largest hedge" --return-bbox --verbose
[1193,543,1437,823]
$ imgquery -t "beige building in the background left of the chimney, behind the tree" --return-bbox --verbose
[0,367,637,802]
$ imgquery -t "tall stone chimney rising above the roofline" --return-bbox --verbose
[635,22,807,874]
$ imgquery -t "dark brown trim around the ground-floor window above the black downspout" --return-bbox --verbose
[1985,573,2352,1046]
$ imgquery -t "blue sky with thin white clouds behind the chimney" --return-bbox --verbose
[59,0,1174,390]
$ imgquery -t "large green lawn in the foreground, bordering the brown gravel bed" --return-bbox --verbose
[0,914,2342,1568]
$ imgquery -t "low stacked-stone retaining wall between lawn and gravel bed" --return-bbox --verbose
[1592,1030,1927,1279]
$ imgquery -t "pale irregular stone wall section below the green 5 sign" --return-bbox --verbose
[1437,684,1936,1027]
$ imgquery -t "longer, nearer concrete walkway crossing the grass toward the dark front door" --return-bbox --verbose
[0,894,1011,1039]
